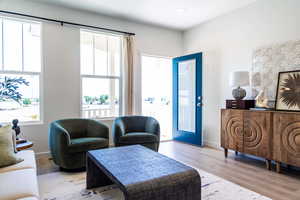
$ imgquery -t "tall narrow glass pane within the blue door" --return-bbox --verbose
[178,59,196,133]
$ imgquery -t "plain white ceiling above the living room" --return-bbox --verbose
[29,0,256,30]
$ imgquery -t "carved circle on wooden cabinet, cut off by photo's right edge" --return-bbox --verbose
[281,122,300,158]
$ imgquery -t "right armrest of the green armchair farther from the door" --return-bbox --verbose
[87,120,109,139]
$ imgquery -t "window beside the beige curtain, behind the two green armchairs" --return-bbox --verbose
[80,30,122,118]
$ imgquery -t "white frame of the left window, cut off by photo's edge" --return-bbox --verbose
[0,15,44,126]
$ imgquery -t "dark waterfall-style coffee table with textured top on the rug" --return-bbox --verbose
[86,145,201,200]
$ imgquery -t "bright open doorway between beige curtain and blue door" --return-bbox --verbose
[142,55,172,140]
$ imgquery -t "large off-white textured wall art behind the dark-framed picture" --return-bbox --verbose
[251,40,300,100]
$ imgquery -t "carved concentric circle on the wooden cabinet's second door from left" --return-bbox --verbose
[244,119,263,149]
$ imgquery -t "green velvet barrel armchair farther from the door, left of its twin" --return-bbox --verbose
[49,119,109,169]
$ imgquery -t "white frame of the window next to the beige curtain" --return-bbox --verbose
[79,29,124,121]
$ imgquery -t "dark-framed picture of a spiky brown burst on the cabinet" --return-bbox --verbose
[275,70,300,112]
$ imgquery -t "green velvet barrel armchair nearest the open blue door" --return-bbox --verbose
[112,116,160,151]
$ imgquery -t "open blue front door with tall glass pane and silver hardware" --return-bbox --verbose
[173,53,202,146]
